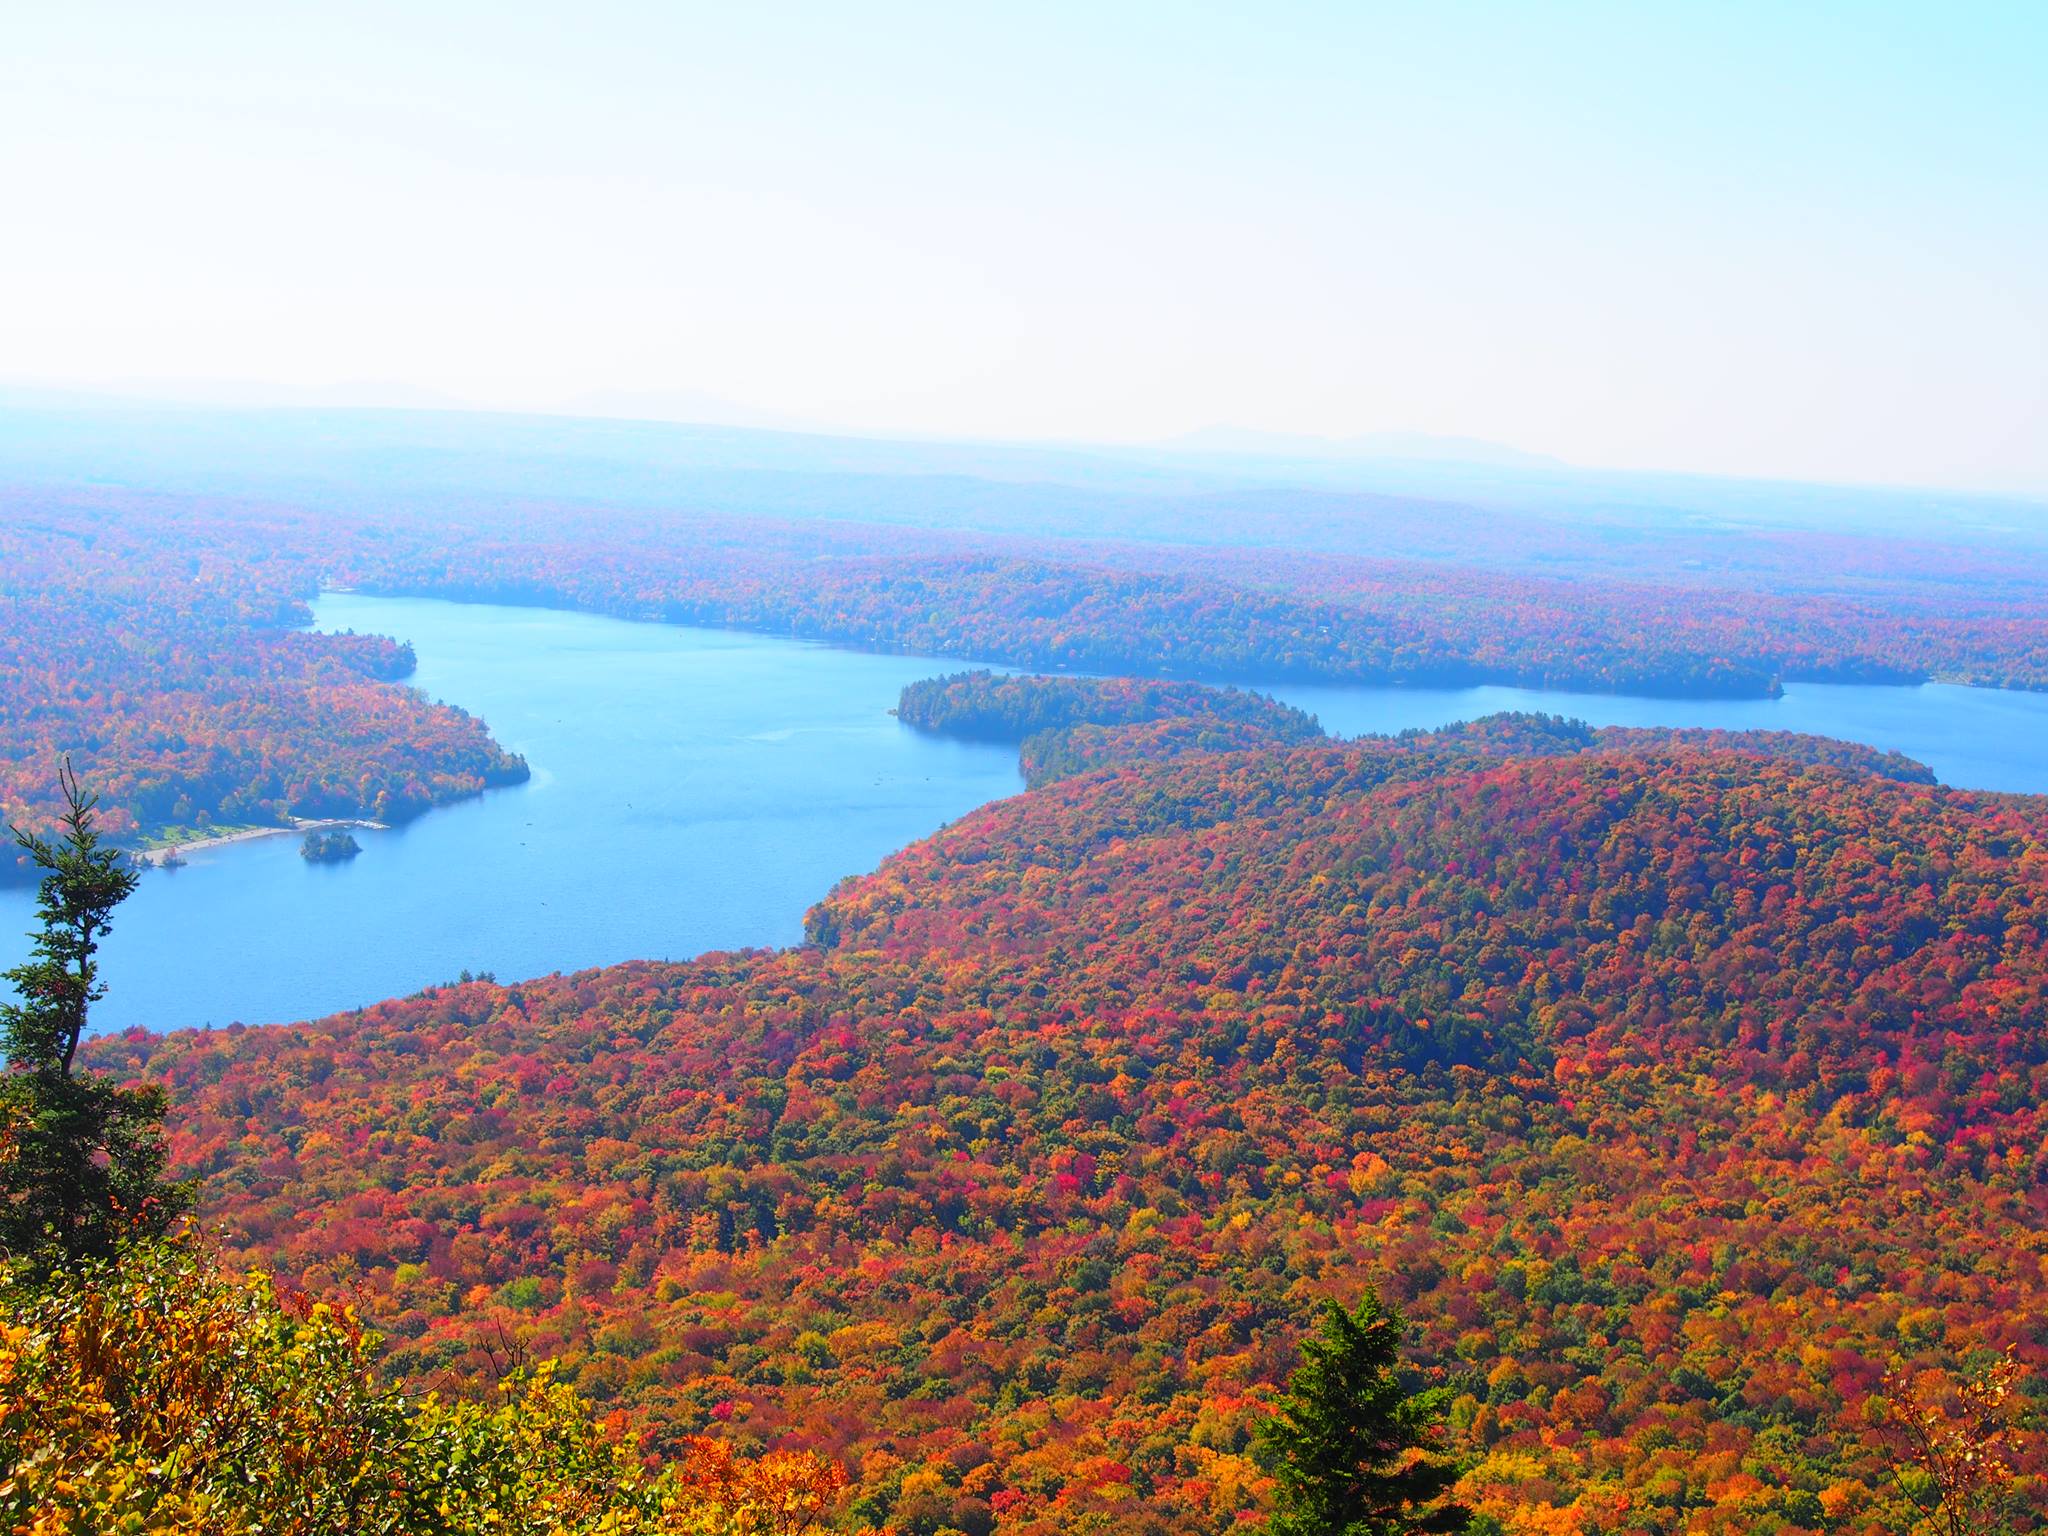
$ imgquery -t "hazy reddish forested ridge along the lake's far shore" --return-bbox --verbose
[317,508,2048,698]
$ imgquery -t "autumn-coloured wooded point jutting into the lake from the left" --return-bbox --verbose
[0,506,526,877]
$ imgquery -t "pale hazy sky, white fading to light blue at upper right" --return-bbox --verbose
[0,0,2048,492]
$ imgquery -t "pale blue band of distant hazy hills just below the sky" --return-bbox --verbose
[0,389,2048,553]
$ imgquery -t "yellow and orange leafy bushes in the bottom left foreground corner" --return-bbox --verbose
[0,1237,844,1536]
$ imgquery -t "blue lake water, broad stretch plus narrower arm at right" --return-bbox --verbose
[0,594,2048,1030]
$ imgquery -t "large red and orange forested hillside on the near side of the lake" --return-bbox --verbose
[96,741,2048,1536]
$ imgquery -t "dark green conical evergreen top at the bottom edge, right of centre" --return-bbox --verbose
[1257,1290,1473,1536]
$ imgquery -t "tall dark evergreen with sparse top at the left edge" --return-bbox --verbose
[0,762,188,1266]
